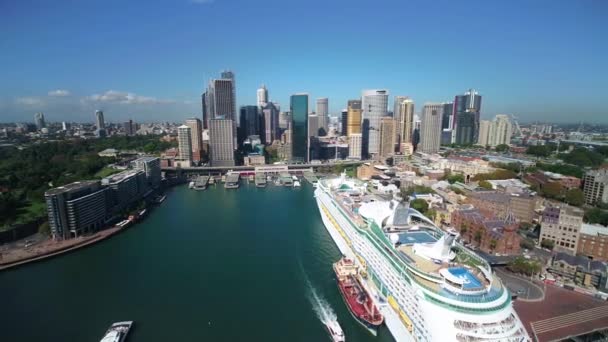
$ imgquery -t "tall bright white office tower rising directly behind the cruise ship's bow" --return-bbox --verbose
[361,89,388,157]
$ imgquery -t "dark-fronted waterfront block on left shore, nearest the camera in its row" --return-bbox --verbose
[44,181,109,240]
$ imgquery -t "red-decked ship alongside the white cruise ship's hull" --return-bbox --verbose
[334,258,384,335]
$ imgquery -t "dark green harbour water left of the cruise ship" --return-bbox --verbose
[0,182,392,342]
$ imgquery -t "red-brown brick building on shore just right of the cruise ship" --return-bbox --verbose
[451,208,521,255]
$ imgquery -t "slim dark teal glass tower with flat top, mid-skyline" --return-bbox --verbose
[289,94,309,162]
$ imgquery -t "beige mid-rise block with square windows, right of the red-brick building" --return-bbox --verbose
[539,204,584,254]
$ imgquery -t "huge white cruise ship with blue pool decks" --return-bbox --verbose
[315,174,530,342]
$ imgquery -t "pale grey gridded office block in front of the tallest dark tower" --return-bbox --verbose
[209,119,235,166]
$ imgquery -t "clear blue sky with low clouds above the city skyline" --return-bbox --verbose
[0,0,608,123]
